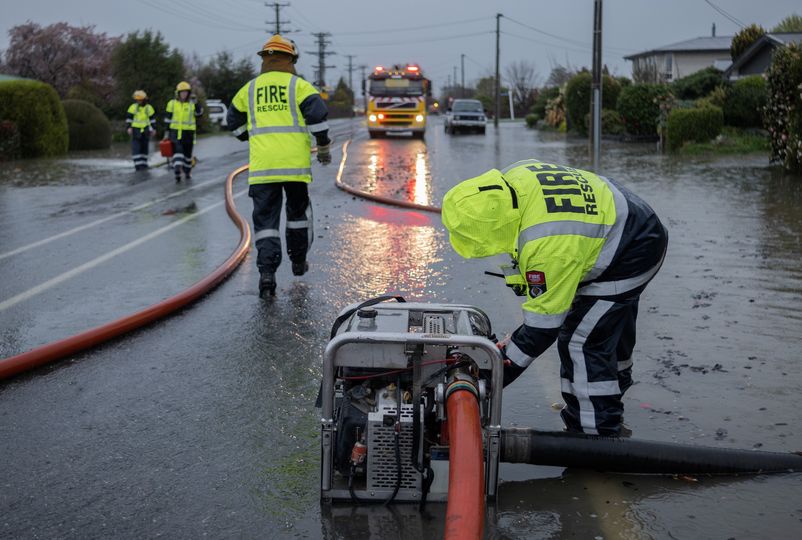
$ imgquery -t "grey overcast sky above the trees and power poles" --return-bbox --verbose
[0,0,802,92]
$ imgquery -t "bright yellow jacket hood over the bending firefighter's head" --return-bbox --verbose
[442,169,521,259]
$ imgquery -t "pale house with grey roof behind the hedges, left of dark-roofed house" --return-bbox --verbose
[624,35,732,82]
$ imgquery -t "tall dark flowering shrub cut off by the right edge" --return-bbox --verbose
[765,43,802,172]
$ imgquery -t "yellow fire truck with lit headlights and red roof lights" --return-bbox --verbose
[366,64,431,139]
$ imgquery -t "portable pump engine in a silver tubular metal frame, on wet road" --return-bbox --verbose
[321,297,502,502]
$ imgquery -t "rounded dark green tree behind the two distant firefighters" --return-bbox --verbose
[111,30,184,118]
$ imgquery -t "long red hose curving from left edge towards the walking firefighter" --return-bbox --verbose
[0,165,251,380]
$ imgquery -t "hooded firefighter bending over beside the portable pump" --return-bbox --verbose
[443,160,668,436]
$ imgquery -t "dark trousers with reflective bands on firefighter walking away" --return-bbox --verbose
[248,182,313,272]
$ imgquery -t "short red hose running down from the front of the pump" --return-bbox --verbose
[445,389,485,540]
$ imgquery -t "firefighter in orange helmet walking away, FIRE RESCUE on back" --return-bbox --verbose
[227,34,331,298]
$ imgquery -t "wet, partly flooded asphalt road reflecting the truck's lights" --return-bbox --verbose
[0,120,802,538]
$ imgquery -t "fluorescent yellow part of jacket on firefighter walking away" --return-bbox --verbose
[231,71,318,184]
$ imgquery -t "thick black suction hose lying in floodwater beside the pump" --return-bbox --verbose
[501,428,802,474]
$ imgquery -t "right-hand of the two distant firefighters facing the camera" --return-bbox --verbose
[164,81,203,182]
